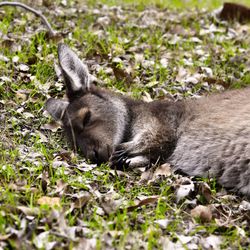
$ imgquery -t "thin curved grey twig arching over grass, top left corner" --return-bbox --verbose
[0,2,57,37]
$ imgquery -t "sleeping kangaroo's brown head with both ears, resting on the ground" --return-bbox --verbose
[46,44,127,163]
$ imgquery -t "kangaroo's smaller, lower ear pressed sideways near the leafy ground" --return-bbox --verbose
[45,98,69,121]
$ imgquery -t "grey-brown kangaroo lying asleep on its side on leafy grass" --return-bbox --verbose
[46,44,250,198]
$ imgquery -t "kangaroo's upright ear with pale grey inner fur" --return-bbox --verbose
[58,43,90,101]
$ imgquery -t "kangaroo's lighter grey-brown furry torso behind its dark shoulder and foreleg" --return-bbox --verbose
[169,88,250,195]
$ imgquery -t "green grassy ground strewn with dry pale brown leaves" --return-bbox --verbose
[0,1,250,249]
